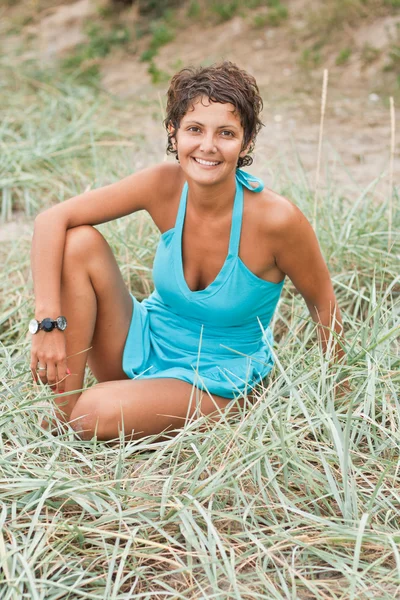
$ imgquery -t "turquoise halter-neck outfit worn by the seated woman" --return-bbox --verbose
[123,169,284,398]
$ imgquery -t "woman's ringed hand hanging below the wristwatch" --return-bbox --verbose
[30,329,69,394]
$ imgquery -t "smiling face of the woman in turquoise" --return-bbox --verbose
[175,96,247,185]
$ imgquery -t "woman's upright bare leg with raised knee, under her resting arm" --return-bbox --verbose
[55,226,132,418]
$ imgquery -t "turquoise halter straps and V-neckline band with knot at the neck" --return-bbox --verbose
[174,169,264,295]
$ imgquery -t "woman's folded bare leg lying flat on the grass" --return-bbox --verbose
[71,379,243,440]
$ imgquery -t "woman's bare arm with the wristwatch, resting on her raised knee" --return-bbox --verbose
[31,163,180,392]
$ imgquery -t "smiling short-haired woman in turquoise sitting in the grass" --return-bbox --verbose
[30,62,342,440]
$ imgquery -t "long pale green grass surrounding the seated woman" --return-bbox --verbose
[0,57,400,600]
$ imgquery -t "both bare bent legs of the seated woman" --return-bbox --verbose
[56,226,241,440]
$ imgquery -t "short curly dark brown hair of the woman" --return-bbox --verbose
[164,61,263,168]
